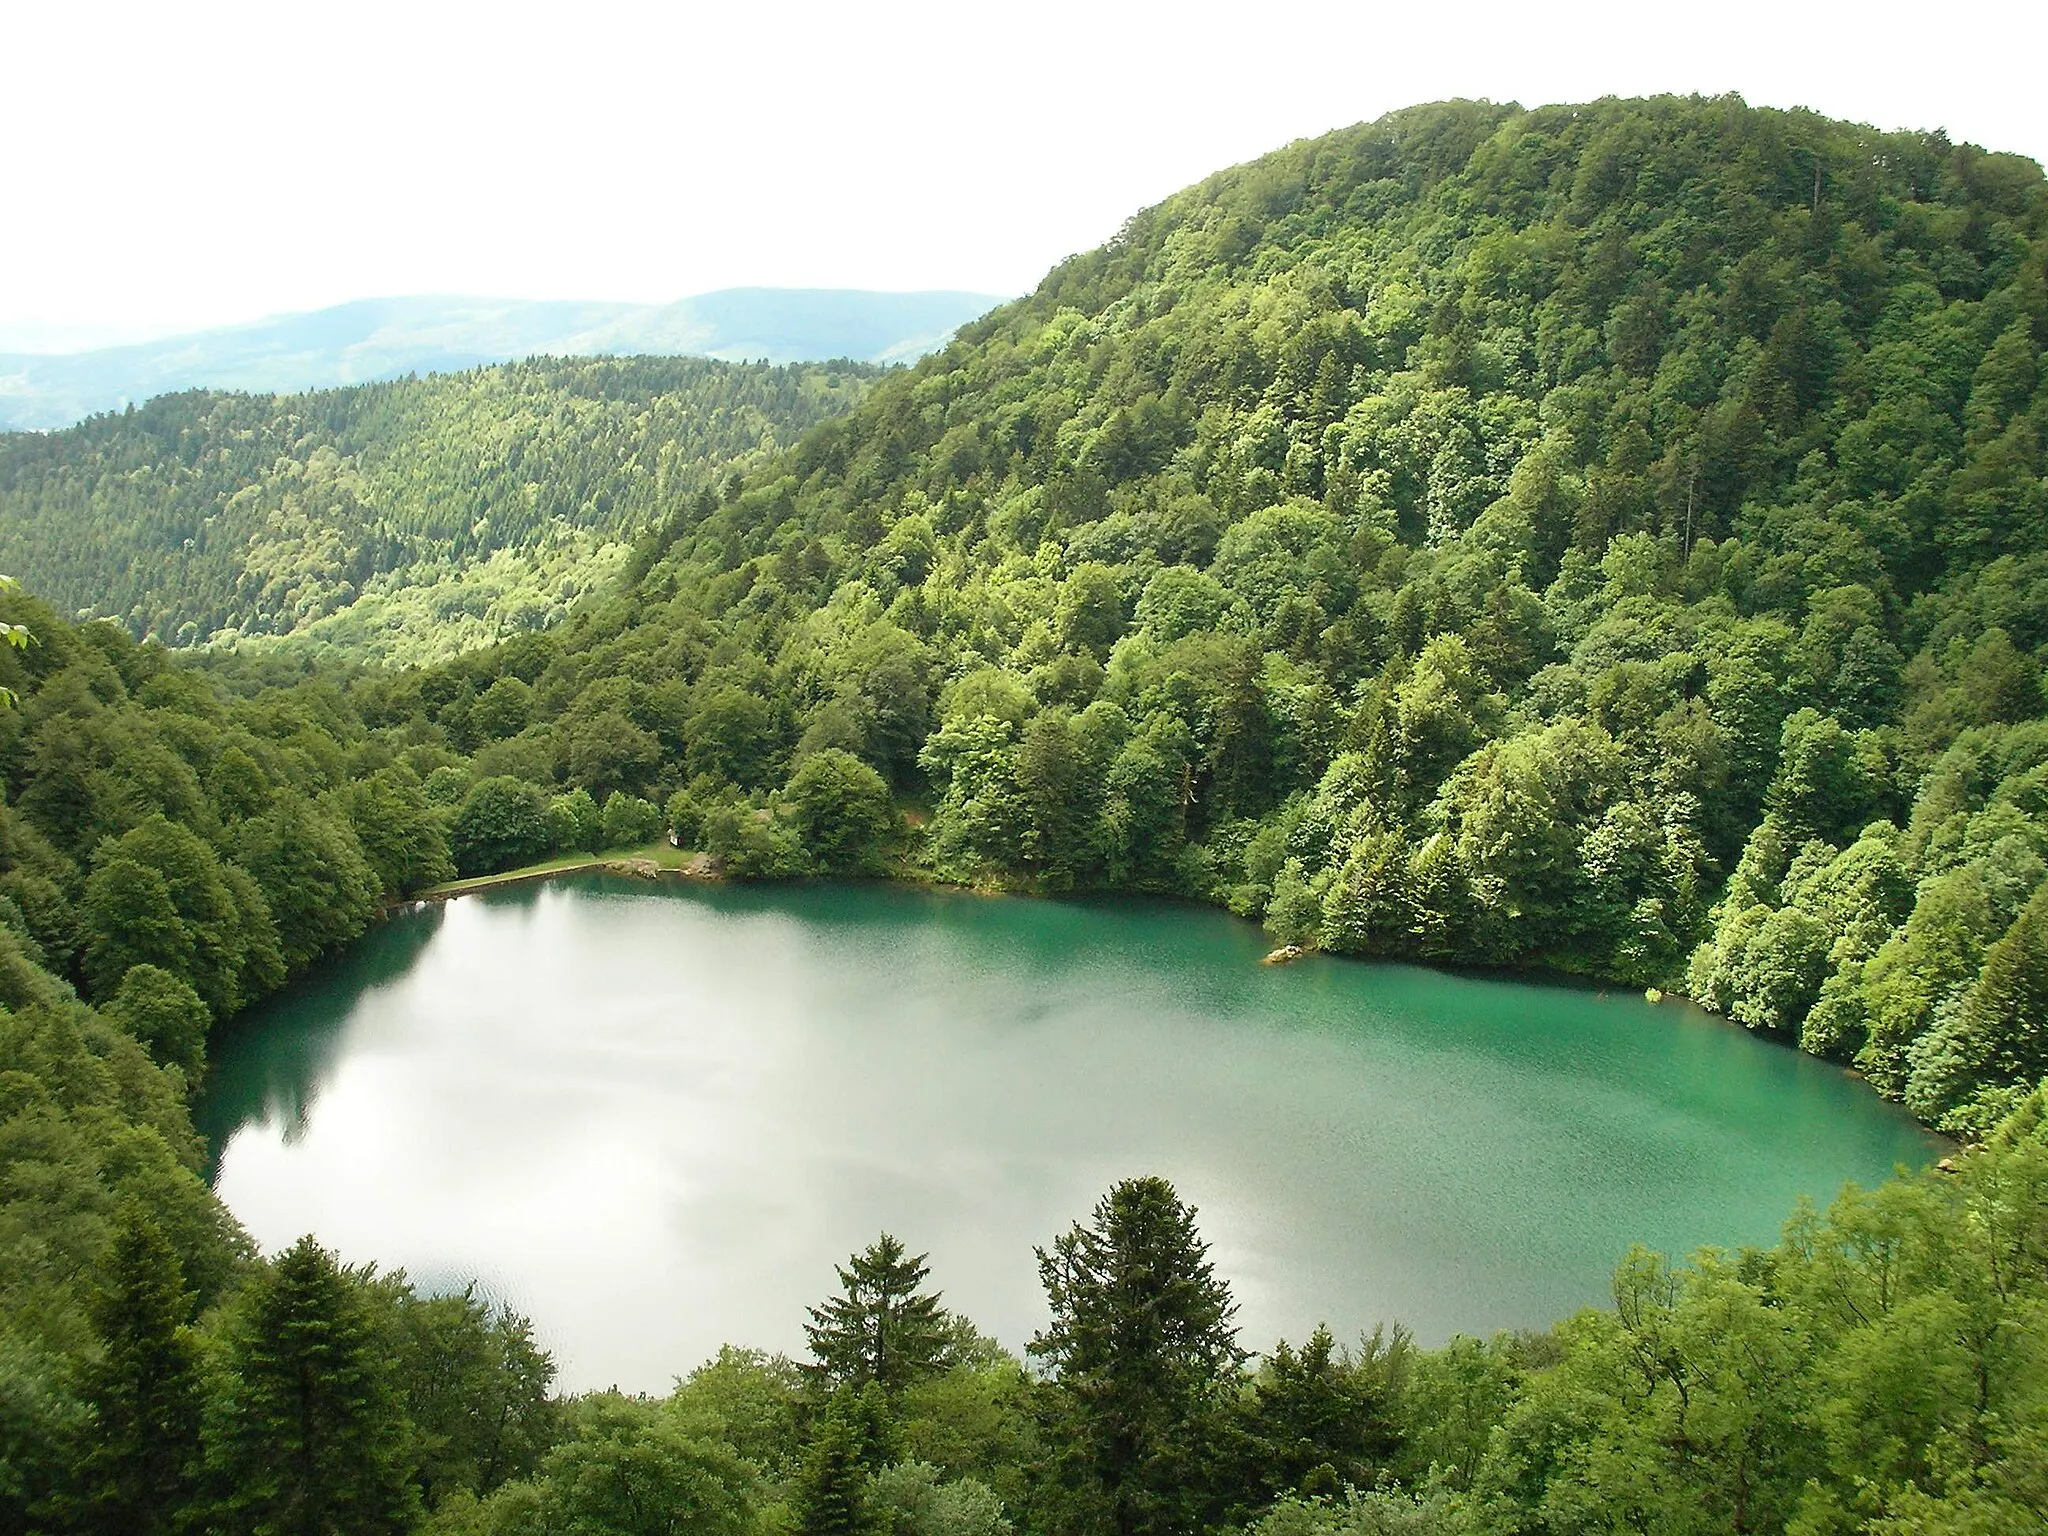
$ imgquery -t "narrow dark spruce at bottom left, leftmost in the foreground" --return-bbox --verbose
[78,1206,201,1536]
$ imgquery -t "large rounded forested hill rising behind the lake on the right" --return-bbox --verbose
[581,98,2048,1126]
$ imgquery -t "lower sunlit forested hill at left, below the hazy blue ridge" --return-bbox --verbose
[0,358,879,662]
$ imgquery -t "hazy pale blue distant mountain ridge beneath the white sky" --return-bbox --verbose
[0,289,1001,430]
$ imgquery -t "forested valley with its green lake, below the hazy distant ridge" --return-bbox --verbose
[0,96,2048,1536]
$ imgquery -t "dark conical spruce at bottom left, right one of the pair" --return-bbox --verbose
[207,1237,420,1536]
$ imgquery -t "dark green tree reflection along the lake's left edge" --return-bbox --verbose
[193,905,444,1182]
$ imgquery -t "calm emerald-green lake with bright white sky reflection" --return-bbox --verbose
[203,877,1937,1391]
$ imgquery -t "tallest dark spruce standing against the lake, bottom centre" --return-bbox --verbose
[1030,1178,1243,1536]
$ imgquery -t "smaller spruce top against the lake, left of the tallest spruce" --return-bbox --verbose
[803,1233,948,1395]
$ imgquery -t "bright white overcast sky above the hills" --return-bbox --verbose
[0,0,2048,350]
